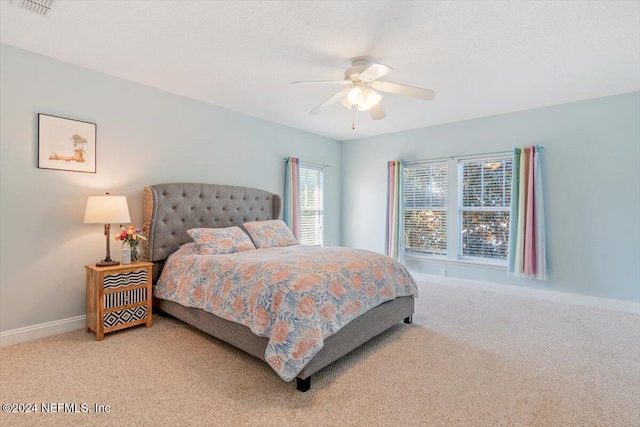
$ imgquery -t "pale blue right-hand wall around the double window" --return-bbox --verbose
[342,92,640,302]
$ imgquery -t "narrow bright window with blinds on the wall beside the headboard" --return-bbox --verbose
[299,162,324,245]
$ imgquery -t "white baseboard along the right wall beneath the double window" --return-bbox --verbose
[411,272,640,314]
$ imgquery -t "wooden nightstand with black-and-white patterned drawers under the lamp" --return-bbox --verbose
[85,261,153,341]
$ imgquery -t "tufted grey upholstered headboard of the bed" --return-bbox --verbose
[143,183,281,268]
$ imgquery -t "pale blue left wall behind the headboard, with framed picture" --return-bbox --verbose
[0,45,342,331]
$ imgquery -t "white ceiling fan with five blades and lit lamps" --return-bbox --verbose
[292,58,436,120]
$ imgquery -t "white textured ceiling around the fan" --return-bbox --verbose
[0,0,640,140]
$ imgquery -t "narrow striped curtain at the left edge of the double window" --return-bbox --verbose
[386,160,404,260]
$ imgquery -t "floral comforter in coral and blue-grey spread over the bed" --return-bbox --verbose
[155,243,417,381]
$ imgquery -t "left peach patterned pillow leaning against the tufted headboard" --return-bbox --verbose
[187,227,256,255]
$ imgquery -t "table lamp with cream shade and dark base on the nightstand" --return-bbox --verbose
[84,193,131,267]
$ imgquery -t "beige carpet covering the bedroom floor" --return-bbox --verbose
[0,283,640,427]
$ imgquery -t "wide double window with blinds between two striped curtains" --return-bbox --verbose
[402,153,512,263]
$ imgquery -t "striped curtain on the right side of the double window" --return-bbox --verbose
[507,146,547,280]
